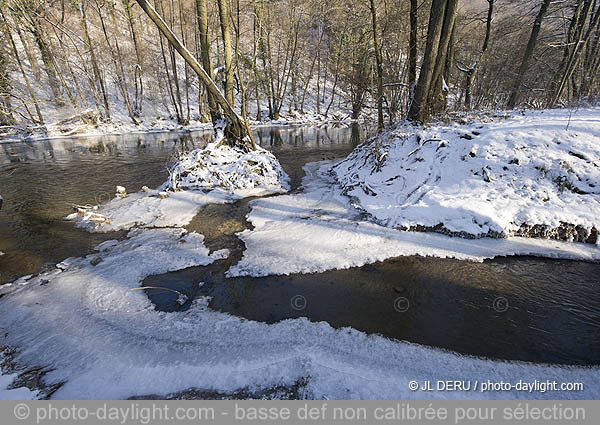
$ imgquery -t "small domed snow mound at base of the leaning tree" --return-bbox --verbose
[166,143,289,193]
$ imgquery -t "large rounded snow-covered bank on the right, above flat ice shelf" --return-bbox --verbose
[334,109,600,243]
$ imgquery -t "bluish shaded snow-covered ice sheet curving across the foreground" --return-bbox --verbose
[0,229,600,399]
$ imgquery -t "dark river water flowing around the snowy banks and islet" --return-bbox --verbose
[0,126,600,365]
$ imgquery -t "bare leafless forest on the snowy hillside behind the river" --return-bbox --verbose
[0,0,600,134]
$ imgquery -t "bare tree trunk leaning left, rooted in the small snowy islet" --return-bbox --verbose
[135,0,256,149]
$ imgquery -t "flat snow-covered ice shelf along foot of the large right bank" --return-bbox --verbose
[228,162,600,277]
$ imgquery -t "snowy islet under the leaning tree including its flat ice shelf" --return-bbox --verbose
[66,143,289,232]
